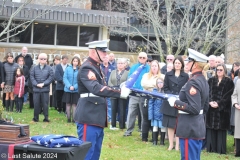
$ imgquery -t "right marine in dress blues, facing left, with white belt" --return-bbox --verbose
[168,49,209,160]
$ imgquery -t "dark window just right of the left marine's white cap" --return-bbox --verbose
[109,35,127,52]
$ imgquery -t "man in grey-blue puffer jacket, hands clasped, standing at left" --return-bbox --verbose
[30,53,54,122]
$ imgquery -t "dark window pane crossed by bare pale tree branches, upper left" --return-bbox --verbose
[9,21,31,43]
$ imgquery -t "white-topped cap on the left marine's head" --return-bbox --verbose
[86,39,110,52]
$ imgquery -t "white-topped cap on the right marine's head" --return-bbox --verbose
[186,48,208,63]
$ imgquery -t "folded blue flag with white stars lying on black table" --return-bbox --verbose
[30,134,83,148]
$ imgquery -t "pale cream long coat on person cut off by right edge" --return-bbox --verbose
[232,79,240,139]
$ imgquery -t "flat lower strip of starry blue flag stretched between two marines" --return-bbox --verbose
[130,88,178,99]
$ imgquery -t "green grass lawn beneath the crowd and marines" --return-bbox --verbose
[3,105,237,160]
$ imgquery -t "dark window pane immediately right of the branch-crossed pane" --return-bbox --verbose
[33,22,55,45]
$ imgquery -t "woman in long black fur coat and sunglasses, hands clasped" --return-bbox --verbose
[206,64,234,154]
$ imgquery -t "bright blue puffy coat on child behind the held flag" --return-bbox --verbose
[148,89,163,121]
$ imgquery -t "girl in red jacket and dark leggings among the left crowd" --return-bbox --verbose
[14,68,25,113]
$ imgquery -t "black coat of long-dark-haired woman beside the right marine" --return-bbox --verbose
[161,70,189,117]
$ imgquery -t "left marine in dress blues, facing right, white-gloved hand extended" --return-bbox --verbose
[74,40,130,160]
